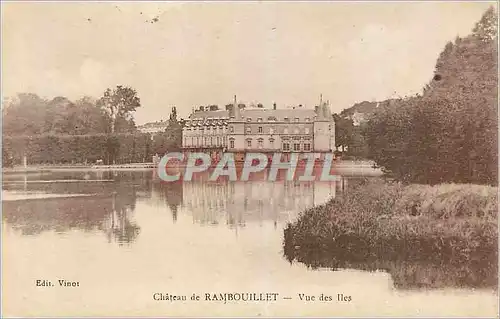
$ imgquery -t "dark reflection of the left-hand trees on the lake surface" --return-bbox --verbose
[2,183,140,245]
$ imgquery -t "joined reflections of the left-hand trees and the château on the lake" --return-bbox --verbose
[3,171,347,244]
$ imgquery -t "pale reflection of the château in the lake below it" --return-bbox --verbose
[155,171,347,227]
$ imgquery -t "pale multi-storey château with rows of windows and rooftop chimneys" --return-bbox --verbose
[182,103,335,160]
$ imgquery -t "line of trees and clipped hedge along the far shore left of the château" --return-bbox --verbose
[2,86,181,167]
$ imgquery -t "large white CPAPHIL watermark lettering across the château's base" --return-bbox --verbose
[157,152,337,182]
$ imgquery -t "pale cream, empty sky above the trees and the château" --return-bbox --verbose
[2,1,495,124]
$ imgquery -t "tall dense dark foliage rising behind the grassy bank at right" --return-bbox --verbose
[365,8,498,184]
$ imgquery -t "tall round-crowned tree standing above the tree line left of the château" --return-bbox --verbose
[97,85,141,133]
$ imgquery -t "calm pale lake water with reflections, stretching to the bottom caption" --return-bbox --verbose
[2,171,498,317]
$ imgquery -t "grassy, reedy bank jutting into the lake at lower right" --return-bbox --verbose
[284,179,498,285]
